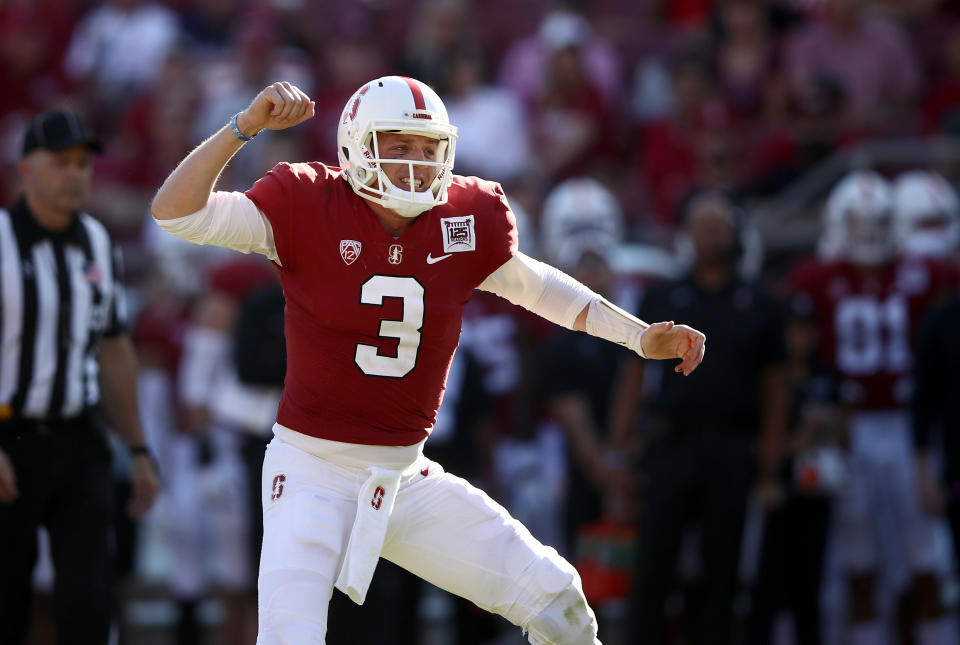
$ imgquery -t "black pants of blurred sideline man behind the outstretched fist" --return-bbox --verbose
[630,427,756,645]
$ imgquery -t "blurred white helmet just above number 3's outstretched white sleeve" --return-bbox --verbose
[540,177,623,268]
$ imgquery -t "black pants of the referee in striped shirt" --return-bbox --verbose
[0,418,113,645]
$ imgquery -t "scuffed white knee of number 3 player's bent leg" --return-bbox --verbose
[524,578,600,645]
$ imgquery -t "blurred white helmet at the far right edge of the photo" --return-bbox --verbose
[893,170,960,257]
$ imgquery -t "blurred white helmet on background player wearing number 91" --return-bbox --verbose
[818,170,896,266]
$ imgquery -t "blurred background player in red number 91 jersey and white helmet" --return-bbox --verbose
[793,171,956,645]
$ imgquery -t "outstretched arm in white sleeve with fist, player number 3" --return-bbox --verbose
[478,252,706,376]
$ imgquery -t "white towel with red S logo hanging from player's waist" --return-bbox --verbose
[335,467,400,605]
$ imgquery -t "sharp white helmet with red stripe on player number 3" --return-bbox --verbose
[337,76,457,217]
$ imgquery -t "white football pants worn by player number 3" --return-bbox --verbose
[257,429,600,645]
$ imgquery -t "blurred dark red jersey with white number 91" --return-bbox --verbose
[792,258,957,410]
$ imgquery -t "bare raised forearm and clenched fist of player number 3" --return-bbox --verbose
[151,82,314,220]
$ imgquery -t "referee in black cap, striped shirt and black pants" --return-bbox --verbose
[0,110,158,645]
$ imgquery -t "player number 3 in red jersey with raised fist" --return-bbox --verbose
[152,76,705,645]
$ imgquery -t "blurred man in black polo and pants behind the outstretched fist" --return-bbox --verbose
[620,190,787,645]
